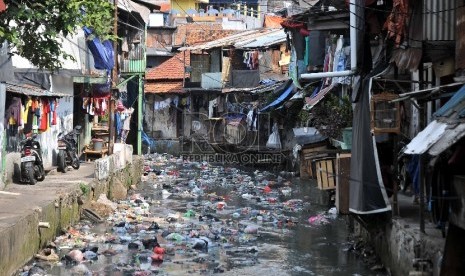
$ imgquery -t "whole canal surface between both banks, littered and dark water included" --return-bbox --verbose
[18,155,387,275]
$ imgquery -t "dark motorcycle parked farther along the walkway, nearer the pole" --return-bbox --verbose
[57,125,81,173]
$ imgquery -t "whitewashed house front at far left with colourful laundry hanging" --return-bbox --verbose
[0,32,83,187]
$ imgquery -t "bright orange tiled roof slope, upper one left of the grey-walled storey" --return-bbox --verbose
[145,52,190,80]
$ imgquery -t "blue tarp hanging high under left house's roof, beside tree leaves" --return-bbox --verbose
[83,27,115,71]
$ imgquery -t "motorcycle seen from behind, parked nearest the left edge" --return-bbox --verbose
[19,135,45,185]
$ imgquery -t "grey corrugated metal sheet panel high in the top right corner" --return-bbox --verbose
[423,0,456,41]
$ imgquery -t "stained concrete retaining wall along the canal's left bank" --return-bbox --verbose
[0,145,143,275]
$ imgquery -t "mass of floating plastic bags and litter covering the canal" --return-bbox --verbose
[21,154,337,275]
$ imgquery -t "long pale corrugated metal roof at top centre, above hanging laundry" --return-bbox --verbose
[179,29,286,51]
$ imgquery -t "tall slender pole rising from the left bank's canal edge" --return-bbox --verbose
[108,0,118,154]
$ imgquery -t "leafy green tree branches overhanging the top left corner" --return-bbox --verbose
[0,0,114,71]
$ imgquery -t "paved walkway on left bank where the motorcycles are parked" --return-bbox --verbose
[0,162,94,233]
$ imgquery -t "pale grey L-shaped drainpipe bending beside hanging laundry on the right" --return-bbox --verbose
[300,0,357,79]
